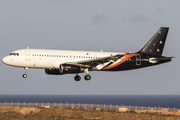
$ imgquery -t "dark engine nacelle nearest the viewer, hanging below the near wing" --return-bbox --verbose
[59,64,84,74]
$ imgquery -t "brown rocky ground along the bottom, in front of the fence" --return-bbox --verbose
[0,106,180,120]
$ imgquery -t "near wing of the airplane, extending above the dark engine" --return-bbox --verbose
[67,54,124,68]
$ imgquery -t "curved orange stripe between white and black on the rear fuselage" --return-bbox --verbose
[102,53,141,70]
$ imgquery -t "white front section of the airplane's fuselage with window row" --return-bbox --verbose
[3,49,122,69]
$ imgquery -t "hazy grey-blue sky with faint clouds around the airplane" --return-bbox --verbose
[0,0,180,95]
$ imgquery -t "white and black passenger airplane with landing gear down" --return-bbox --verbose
[2,27,174,81]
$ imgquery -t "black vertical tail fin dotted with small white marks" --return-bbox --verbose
[139,27,169,56]
